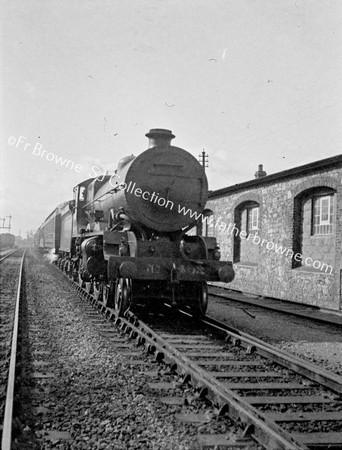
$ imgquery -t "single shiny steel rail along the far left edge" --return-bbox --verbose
[1,250,26,450]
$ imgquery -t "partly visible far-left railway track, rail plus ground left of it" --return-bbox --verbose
[0,249,26,450]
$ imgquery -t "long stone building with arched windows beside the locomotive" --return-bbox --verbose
[203,155,342,310]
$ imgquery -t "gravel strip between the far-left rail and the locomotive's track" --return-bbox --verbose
[15,252,211,450]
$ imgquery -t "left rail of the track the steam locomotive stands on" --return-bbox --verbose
[60,273,308,450]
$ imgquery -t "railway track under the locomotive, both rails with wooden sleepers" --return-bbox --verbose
[57,264,342,450]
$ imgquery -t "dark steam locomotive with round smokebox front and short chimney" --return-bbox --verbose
[36,129,234,317]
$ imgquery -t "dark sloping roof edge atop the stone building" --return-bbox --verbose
[209,155,342,198]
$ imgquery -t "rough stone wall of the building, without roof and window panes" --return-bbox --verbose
[207,168,342,310]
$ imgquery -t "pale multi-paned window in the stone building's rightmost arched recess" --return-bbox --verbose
[312,195,334,235]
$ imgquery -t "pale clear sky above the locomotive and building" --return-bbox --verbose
[0,0,342,237]
